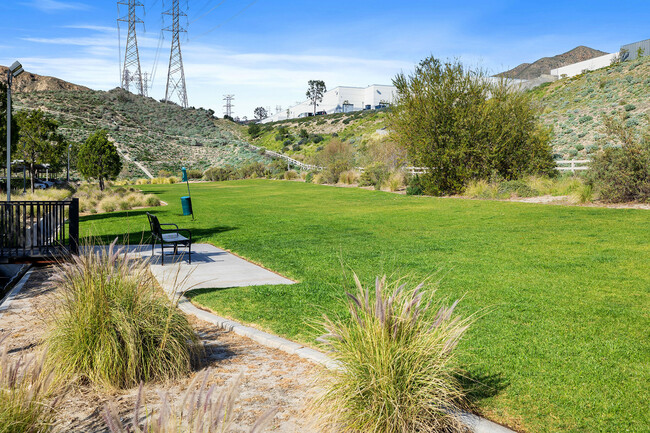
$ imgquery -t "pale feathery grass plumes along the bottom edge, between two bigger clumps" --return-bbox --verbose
[102,370,277,433]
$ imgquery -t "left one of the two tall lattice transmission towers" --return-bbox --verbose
[117,0,145,95]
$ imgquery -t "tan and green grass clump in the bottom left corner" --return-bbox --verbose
[0,336,58,433]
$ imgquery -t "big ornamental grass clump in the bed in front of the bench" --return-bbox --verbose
[46,241,200,388]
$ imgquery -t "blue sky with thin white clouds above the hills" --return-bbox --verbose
[0,0,650,117]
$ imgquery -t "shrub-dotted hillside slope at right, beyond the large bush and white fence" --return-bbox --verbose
[532,57,650,159]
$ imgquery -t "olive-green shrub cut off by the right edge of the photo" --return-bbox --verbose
[589,116,650,202]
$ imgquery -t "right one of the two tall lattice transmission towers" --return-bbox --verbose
[163,0,187,108]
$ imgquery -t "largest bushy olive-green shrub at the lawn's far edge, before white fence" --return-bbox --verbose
[389,57,555,194]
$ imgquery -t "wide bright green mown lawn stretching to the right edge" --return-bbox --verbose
[82,180,650,432]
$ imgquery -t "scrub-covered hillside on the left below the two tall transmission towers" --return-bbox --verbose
[15,89,262,177]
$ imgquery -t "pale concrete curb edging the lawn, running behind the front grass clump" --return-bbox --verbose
[178,296,516,433]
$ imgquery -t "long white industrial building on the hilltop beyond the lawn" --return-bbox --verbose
[261,84,397,123]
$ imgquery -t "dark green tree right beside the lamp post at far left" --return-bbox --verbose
[12,110,67,192]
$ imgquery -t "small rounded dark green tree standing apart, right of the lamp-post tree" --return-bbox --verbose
[77,130,122,191]
